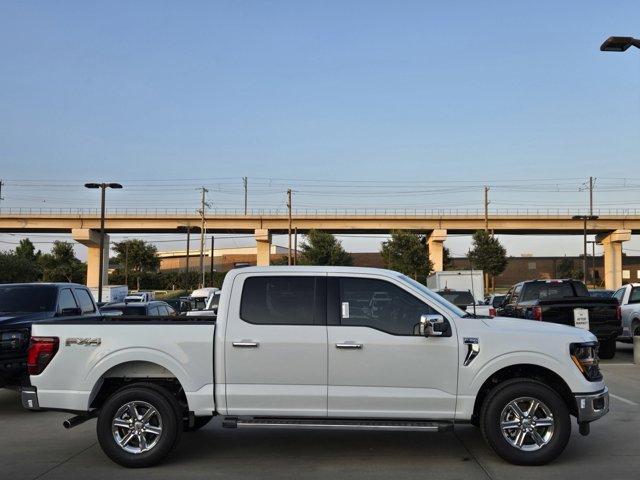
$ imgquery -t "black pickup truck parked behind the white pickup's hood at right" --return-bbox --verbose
[497,280,622,358]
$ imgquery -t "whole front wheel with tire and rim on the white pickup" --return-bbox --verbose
[480,379,571,465]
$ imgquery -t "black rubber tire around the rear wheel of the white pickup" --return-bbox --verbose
[96,384,182,468]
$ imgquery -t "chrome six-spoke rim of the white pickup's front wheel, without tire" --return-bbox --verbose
[500,397,555,452]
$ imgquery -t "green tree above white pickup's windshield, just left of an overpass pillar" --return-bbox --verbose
[380,230,433,283]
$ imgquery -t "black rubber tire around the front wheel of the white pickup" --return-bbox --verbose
[480,378,571,465]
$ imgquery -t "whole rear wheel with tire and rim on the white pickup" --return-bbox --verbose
[97,386,182,468]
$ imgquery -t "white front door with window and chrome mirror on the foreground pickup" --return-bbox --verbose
[327,276,458,419]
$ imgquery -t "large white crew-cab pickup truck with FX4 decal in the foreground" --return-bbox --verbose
[22,267,609,467]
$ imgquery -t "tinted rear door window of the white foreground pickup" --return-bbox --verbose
[240,276,316,325]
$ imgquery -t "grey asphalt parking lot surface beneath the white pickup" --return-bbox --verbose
[0,344,640,480]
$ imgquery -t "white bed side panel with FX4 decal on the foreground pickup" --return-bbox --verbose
[30,317,215,411]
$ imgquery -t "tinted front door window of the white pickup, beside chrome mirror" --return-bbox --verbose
[340,278,435,335]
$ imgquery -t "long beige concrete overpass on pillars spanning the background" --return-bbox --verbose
[0,208,640,288]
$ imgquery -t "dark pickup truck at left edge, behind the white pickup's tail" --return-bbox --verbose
[0,283,98,387]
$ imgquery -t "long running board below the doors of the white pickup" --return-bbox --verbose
[222,417,453,432]
